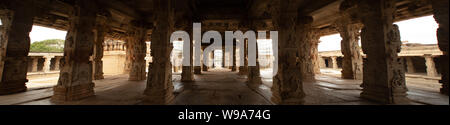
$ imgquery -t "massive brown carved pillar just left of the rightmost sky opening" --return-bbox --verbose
[358,0,408,104]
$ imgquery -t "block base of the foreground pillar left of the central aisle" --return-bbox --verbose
[142,88,175,105]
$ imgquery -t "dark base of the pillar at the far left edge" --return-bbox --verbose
[0,79,28,95]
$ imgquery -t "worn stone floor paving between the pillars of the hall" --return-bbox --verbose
[0,69,449,105]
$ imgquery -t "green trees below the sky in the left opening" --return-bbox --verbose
[30,39,64,53]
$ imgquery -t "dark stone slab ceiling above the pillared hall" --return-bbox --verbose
[15,0,432,38]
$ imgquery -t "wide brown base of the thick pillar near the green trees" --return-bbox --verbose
[51,83,95,102]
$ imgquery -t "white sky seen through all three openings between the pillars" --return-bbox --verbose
[6,16,438,51]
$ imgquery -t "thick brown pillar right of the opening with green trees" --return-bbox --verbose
[52,1,97,102]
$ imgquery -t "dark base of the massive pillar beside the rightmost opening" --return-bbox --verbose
[360,87,410,104]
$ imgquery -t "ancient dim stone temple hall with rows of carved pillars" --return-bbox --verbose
[0,0,449,105]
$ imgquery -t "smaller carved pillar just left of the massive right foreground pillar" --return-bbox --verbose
[335,12,362,79]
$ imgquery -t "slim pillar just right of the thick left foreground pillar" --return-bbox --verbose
[92,14,108,80]
